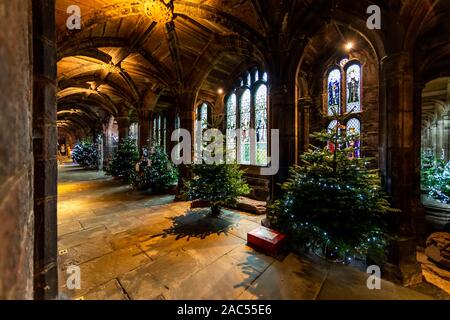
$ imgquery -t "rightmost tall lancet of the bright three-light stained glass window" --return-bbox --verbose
[255,85,267,166]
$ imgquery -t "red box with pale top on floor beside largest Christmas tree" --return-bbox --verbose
[247,226,286,257]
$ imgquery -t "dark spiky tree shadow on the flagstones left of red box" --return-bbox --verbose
[154,209,236,240]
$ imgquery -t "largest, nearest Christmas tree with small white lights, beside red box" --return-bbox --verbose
[269,116,396,261]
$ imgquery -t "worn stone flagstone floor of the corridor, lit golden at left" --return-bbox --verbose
[58,164,440,300]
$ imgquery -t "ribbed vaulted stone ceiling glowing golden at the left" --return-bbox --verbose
[56,0,450,135]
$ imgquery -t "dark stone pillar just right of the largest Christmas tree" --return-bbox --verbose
[381,52,422,285]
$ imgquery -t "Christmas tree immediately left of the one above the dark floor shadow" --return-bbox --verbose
[132,146,178,193]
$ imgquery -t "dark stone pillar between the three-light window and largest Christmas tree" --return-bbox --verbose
[269,84,297,199]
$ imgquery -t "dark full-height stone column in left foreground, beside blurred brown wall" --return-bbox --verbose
[32,0,58,299]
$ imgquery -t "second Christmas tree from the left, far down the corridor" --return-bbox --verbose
[106,139,139,182]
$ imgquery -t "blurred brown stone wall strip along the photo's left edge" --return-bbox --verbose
[0,0,34,299]
